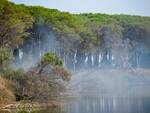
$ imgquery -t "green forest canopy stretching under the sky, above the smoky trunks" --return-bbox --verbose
[0,0,150,50]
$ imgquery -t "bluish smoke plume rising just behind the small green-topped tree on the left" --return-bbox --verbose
[14,27,62,70]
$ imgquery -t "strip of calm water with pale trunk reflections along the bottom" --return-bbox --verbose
[23,97,150,113]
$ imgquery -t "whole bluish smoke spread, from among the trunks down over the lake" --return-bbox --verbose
[10,23,150,113]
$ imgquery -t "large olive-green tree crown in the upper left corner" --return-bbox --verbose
[0,0,34,47]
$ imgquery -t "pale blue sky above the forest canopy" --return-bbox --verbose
[11,0,150,16]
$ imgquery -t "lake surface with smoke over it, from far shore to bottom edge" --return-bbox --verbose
[42,71,150,113]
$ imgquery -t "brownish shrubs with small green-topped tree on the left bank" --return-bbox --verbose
[0,53,71,102]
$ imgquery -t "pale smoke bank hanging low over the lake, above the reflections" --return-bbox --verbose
[71,69,150,97]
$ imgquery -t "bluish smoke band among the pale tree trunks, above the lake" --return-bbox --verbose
[14,23,150,70]
